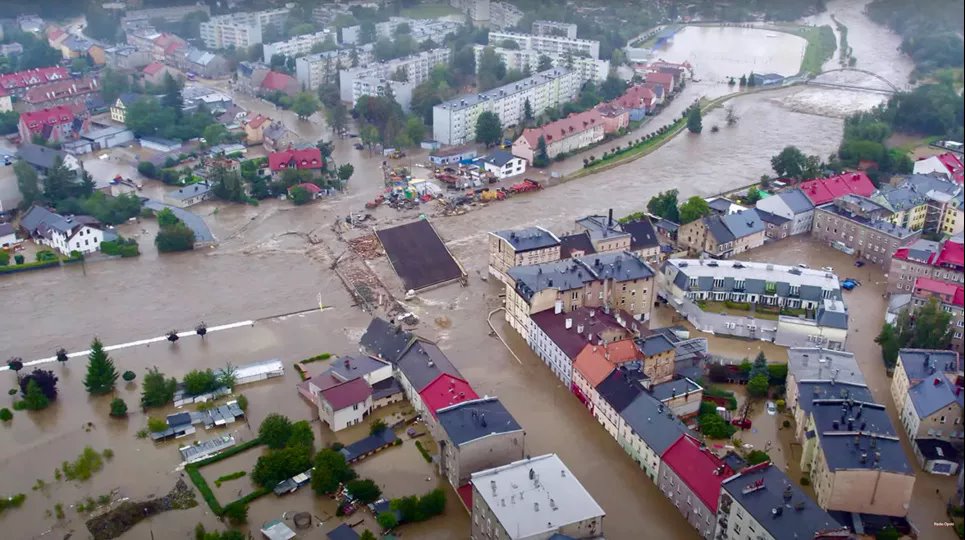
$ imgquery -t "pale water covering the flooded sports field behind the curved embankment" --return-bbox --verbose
[655,26,807,81]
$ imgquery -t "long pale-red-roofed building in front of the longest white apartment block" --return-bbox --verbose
[513,109,606,163]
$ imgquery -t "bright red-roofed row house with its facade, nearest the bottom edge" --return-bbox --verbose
[657,435,734,539]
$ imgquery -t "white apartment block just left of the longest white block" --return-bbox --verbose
[338,49,450,104]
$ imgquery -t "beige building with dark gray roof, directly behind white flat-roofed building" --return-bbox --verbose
[433,396,526,488]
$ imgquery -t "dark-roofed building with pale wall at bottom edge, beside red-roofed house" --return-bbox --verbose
[714,461,851,540]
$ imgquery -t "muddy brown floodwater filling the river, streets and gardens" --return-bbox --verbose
[0,1,949,539]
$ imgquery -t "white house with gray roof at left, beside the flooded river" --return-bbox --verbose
[20,205,104,255]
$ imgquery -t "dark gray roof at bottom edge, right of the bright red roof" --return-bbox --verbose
[721,463,841,538]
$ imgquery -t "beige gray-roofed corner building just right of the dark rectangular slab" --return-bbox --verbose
[489,227,560,283]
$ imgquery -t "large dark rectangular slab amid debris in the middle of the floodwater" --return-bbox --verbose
[375,219,463,290]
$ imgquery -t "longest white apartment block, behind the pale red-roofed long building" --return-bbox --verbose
[432,68,581,144]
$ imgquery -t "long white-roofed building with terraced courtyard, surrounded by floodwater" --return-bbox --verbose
[658,259,848,350]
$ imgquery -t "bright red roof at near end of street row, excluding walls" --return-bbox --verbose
[663,435,734,514]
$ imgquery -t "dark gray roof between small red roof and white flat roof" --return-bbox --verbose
[436,397,523,446]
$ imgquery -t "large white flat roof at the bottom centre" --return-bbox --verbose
[471,454,605,538]
